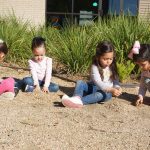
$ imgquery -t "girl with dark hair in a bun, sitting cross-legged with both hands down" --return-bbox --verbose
[23,37,59,92]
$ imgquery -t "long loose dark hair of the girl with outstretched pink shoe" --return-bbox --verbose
[92,41,118,80]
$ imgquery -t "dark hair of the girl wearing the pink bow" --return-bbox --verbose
[133,44,150,62]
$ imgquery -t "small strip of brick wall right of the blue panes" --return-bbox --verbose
[139,0,150,20]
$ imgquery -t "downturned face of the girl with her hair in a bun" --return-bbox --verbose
[33,46,45,62]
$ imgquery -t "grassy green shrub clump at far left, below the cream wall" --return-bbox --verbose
[0,16,31,65]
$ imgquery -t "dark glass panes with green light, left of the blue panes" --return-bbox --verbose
[47,0,99,26]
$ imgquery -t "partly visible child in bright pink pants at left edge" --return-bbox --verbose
[0,39,15,100]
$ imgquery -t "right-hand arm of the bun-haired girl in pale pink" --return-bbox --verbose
[43,58,52,92]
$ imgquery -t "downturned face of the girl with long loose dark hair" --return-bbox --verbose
[99,52,114,68]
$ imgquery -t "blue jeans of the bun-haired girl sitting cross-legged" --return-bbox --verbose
[23,77,59,92]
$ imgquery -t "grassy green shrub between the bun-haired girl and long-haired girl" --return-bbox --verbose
[49,27,97,73]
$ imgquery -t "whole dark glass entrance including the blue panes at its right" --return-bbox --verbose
[47,0,139,26]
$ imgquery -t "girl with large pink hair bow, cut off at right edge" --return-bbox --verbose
[128,41,150,106]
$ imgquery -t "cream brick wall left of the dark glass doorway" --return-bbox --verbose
[0,0,46,26]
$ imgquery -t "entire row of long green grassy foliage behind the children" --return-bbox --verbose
[0,15,150,80]
